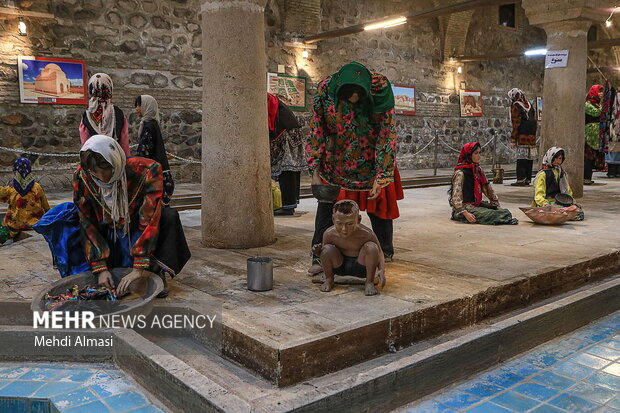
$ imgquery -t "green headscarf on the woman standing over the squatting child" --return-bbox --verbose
[328,62,394,114]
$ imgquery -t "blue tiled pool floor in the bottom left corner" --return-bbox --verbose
[0,363,163,413]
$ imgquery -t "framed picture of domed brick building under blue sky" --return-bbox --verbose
[17,56,88,105]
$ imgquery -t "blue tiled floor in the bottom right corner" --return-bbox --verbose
[394,312,620,413]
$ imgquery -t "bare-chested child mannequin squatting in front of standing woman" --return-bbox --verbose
[313,199,385,295]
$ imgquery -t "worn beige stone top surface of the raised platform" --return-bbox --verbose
[0,171,620,384]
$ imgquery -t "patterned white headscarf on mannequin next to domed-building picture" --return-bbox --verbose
[88,73,120,139]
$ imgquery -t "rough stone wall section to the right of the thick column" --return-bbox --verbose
[267,0,545,168]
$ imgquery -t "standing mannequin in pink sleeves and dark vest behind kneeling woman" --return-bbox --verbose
[80,73,130,156]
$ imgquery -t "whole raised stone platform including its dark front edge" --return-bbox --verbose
[0,178,620,386]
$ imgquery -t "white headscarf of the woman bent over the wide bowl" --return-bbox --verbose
[80,135,129,235]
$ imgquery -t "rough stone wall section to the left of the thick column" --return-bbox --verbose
[0,0,202,179]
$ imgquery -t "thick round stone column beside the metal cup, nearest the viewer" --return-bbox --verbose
[202,0,275,248]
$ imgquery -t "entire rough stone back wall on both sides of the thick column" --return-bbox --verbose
[0,0,615,187]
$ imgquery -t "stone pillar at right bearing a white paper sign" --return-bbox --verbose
[521,0,611,198]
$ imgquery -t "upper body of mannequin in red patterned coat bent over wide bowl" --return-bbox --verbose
[73,135,189,294]
